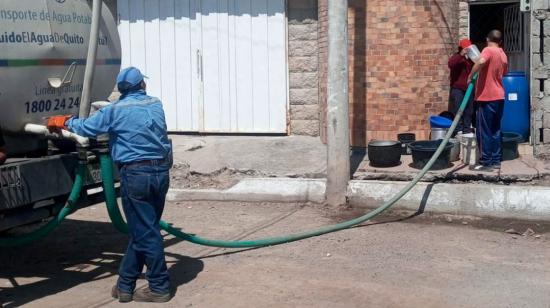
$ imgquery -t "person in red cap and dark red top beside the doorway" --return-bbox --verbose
[448,39,474,134]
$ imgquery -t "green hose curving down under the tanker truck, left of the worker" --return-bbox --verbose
[0,163,86,247]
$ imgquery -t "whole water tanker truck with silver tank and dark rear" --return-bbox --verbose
[0,0,121,232]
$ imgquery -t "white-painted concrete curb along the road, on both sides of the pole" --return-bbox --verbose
[167,178,550,221]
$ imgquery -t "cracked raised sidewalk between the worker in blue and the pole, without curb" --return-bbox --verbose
[174,135,327,178]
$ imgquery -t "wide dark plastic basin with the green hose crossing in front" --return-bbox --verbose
[409,140,453,170]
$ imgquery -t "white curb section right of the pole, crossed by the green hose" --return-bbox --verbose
[348,181,550,220]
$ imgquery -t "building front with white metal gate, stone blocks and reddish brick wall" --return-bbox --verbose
[117,0,550,156]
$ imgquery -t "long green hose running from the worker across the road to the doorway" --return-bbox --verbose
[104,79,474,248]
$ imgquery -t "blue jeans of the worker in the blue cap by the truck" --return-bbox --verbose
[118,162,170,294]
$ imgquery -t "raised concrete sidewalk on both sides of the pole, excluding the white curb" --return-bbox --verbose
[171,135,550,188]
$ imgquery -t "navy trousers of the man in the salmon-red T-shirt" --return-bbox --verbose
[476,100,504,166]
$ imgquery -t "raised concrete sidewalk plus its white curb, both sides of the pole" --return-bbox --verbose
[168,136,550,220]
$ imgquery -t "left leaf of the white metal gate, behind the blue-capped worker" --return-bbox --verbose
[118,0,202,131]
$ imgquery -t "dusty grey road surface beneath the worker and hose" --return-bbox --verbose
[0,202,550,308]
